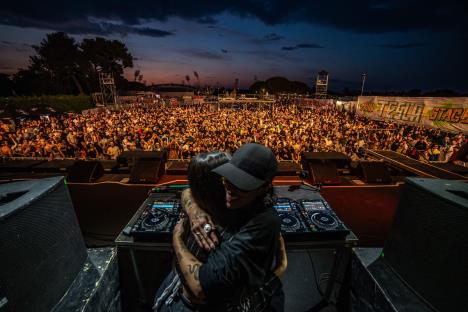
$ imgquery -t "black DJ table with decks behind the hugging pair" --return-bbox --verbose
[115,185,358,311]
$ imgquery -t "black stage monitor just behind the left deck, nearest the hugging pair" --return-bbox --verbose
[129,151,167,183]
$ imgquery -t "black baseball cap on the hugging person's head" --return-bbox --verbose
[212,143,278,191]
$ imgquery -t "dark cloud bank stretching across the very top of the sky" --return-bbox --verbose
[0,0,468,34]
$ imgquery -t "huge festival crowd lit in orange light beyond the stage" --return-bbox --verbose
[0,104,465,162]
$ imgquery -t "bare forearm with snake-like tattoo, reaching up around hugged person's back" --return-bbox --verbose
[172,217,205,300]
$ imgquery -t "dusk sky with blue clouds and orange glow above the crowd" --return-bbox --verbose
[0,0,468,92]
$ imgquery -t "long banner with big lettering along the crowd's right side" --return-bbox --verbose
[357,96,468,133]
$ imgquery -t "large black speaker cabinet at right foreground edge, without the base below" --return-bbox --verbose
[383,178,468,311]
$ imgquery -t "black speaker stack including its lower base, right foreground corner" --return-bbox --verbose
[352,178,468,311]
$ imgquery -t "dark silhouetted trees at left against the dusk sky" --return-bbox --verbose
[0,32,144,96]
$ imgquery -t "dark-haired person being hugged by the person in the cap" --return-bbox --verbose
[153,151,287,312]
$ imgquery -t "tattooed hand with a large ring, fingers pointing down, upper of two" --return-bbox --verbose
[181,189,218,251]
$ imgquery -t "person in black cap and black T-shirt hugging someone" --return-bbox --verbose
[173,143,284,311]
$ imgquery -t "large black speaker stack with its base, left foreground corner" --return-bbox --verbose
[0,177,121,312]
